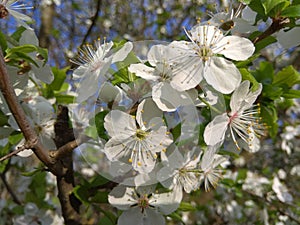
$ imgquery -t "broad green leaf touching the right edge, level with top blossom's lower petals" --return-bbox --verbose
[273,66,300,87]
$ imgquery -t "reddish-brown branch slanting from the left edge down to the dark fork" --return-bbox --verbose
[0,48,51,167]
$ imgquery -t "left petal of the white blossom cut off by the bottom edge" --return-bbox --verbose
[108,185,137,210]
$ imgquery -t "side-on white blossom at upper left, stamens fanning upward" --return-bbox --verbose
[71,39,133,102]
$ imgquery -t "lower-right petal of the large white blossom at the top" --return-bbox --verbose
[204,57,242,94]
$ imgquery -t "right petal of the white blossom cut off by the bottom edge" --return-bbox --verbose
[149,190,182,215]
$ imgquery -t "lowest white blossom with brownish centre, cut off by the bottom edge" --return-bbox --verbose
[108,186,181,225]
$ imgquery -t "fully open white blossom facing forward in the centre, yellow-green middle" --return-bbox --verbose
[104,100,172,173]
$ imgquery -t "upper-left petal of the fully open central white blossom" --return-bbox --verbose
[104,110,136,139]
